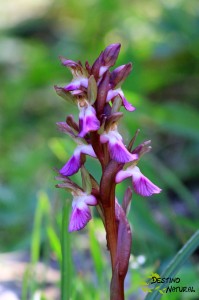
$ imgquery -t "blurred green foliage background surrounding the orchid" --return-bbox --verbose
[0,0,199,300]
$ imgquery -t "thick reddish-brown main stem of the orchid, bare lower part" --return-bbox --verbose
[91,132,125,300]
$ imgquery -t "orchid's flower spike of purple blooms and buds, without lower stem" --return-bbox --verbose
[55,44,161,231]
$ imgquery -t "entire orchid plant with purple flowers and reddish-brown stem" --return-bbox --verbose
[55,44,161,300]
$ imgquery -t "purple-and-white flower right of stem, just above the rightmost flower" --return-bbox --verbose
[100,130,138,163]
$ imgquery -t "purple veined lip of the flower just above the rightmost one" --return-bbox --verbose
[108,141,138,163]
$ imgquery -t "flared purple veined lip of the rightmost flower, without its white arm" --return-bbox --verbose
[132,167,161,196]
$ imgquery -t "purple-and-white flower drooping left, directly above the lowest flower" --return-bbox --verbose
[59,145,96,176]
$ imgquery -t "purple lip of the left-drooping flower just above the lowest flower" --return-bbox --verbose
[59,153,81,176]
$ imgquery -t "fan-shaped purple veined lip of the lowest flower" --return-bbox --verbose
[68,201,92,232]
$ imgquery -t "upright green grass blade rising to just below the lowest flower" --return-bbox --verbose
[61,201,72,300]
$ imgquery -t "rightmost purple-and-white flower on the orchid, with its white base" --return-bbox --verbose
[115,166,161,196]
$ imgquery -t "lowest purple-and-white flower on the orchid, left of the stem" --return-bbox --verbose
[68,192,97,232]
